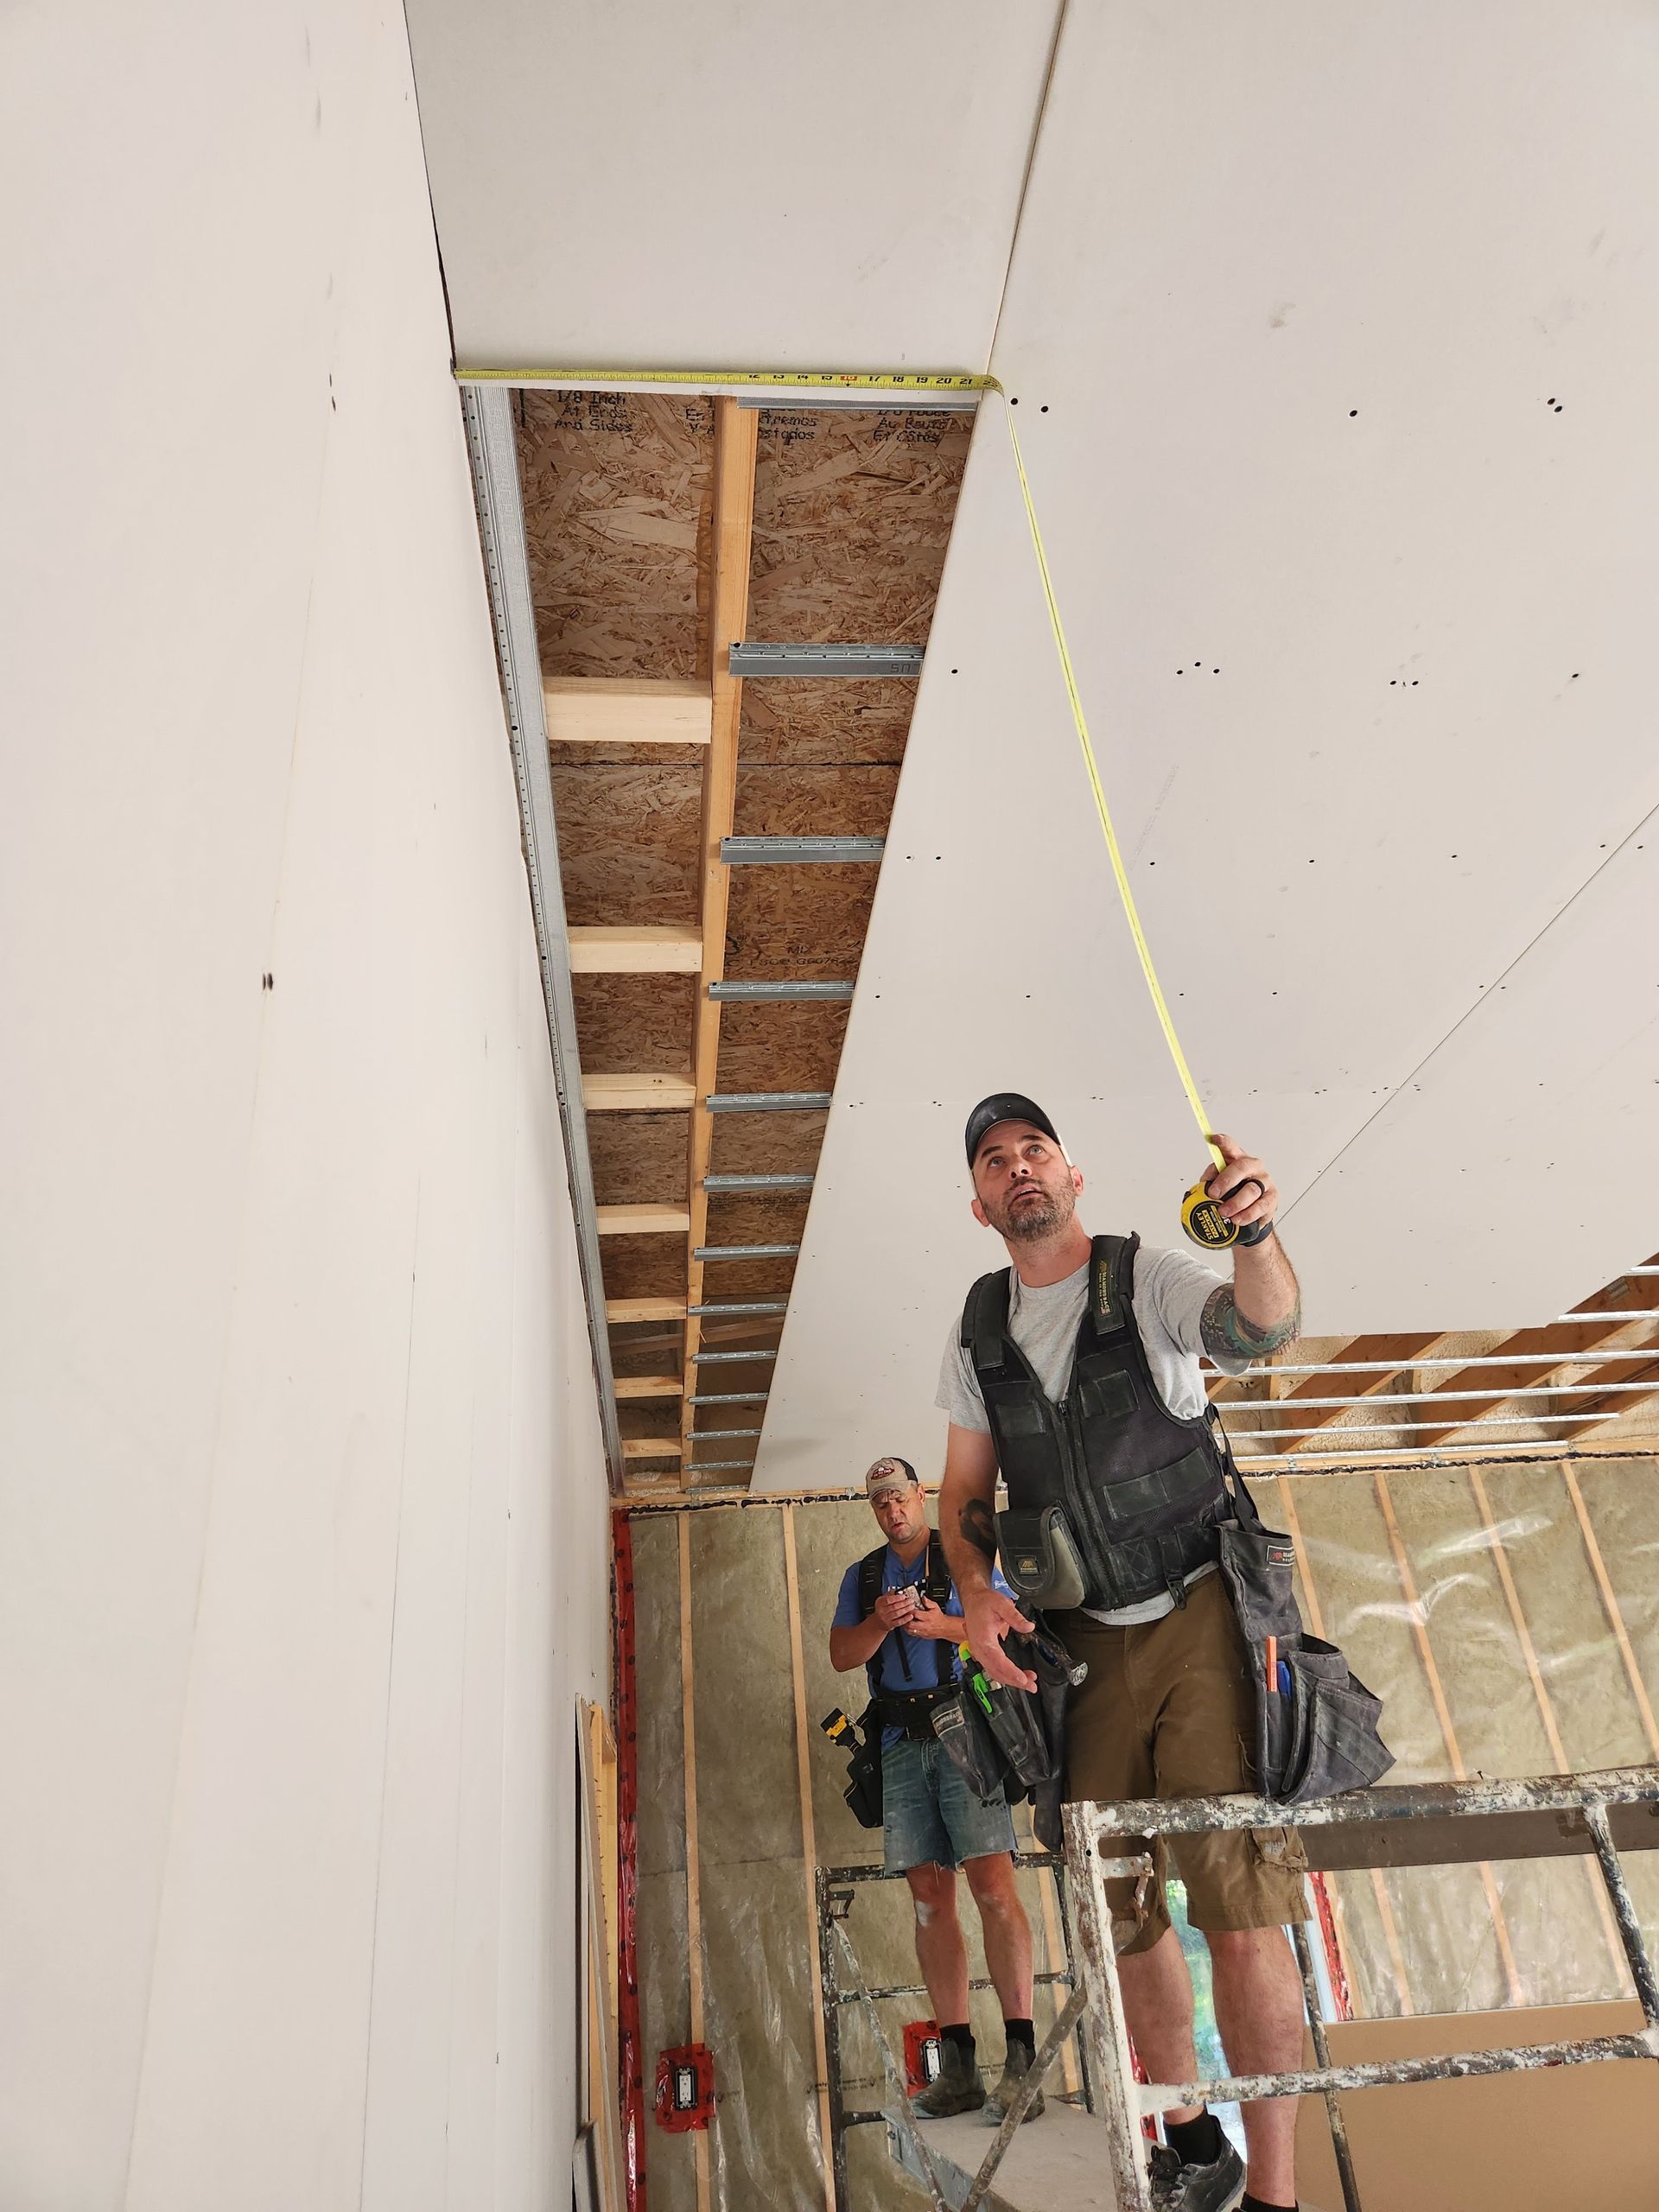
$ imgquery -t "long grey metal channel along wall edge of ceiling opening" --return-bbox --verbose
[460,385,626,1497]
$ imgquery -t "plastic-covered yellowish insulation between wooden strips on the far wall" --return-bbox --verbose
[635,1459,1659,2212]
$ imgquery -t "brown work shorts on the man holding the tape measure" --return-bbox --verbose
[1051,1573,1307,1951]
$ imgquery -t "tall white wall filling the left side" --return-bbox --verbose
[0,0,606,2212]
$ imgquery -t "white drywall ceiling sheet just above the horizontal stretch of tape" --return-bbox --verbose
[410,0,1058,370]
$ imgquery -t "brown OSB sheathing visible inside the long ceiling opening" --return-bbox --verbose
[518,391,971,1438]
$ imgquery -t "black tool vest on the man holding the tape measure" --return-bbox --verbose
[963,1236,1232,1611]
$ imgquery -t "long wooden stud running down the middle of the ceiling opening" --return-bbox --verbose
[686,398,761,1459]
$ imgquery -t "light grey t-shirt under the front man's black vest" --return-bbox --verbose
[933,1245,1249,1628]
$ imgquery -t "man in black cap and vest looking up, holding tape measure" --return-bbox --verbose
[938,1090,1305,2212]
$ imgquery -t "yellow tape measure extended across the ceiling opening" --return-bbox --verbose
[455,353,1238,1249]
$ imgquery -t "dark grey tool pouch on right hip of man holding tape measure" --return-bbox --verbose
[1219,1522,1394,1805]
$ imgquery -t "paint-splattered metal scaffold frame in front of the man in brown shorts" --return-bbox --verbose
[1062,1767,1659,2212]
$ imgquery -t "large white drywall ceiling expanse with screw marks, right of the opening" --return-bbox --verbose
[757,0,1659,1486]
